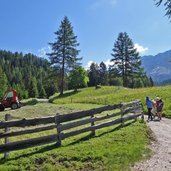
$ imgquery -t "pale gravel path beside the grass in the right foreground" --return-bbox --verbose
[132,118,171,171]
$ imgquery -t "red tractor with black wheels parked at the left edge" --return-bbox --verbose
[0,90,21,111]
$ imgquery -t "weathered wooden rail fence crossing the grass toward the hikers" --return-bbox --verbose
[0,100,142,157]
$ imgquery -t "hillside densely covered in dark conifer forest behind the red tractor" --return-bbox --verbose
[0,50,55,98]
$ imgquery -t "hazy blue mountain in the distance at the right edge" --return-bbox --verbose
[141,50,171,84]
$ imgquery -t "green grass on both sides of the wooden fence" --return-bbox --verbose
[0,86,167,171]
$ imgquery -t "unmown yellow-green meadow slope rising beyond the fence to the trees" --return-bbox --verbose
[51,86,171,116]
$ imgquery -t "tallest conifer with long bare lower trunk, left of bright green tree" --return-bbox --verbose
[48,16,82,95]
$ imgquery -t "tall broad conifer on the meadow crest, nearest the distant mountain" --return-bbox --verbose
[111,32,142,87]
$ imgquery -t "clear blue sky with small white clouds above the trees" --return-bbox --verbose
[0,0,171,67]
